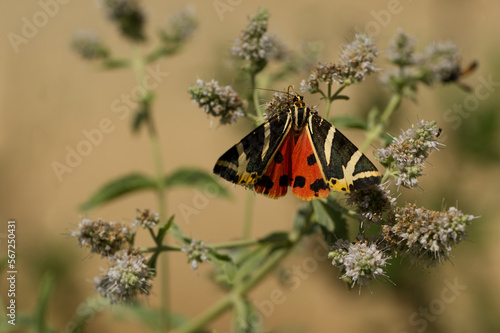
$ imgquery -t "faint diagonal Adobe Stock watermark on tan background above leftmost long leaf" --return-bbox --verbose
[51,65,169,182]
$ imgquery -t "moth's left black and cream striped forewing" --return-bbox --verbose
[214,112,292,185]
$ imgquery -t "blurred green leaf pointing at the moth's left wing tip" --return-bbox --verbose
[164,168,230,198]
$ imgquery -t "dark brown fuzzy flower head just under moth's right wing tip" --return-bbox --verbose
[347,184,396,223]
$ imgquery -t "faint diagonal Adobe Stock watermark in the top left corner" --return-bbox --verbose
[7,0,71,54]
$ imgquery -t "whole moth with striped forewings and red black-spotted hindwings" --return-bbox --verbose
[213,93,380,200]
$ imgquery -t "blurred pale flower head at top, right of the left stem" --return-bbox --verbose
[160,8,198,43]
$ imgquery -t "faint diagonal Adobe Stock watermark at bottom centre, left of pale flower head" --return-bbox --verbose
[240,239,329,326]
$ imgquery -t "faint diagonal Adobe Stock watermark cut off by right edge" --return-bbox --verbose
[442,74,500,140]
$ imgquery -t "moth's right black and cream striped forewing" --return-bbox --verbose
[307,113,380,192]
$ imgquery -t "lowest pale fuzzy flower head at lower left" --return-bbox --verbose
[95,250,152,303]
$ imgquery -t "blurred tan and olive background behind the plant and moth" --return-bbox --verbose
[0,0,500,332]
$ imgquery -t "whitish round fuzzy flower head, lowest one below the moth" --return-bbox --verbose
[328,239,390,287]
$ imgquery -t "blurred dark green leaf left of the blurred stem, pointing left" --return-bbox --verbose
[80,173,156,210]
